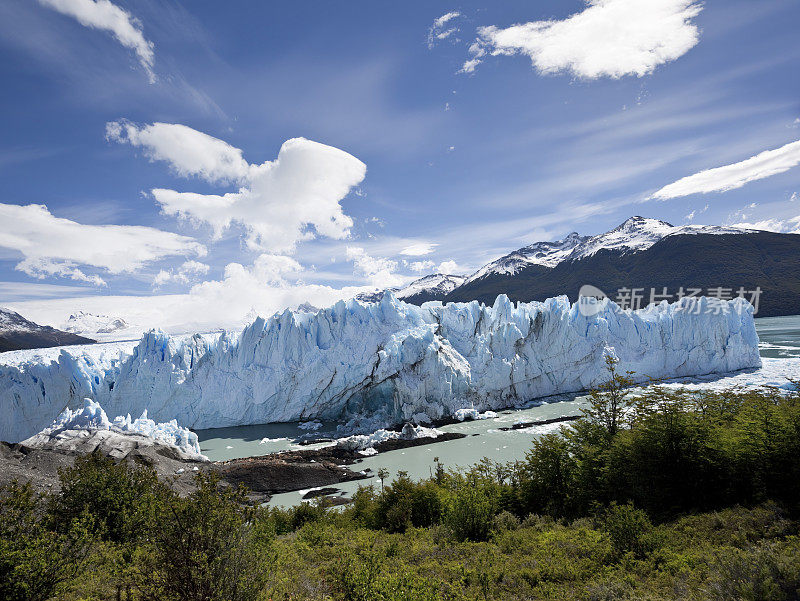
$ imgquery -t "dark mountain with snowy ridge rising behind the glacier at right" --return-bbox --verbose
[382,216,800,315]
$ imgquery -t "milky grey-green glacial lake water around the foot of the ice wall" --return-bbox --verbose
[197,316,800,506]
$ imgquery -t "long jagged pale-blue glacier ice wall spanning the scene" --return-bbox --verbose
[0,294,760,441]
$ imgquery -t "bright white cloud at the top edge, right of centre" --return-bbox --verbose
[461,0,702,79]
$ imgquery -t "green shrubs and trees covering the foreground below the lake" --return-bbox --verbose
[0,362,800,601]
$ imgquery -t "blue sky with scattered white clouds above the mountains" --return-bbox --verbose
[0,0,800,325]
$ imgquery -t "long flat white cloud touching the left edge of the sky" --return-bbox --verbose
[0,204,206,285]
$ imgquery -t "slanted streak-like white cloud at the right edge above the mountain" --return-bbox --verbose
[652,141,800,200]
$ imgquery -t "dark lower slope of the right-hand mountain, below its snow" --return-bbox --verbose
[438,231,800,317]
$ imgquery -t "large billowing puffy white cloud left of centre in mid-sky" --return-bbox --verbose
[108,122,367,252]
